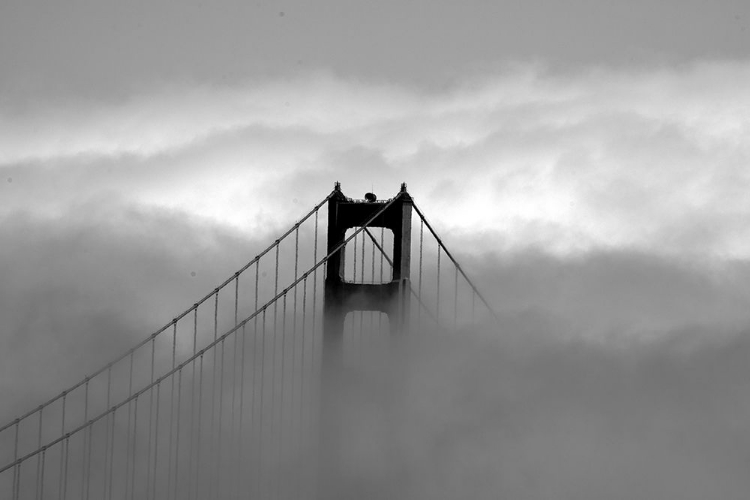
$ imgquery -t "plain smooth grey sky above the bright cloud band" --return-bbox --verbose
[0,0,750,100]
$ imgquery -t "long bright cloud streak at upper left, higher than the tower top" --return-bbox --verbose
[0,75,424,164]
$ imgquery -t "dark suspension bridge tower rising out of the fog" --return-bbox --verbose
[318,182,413,500]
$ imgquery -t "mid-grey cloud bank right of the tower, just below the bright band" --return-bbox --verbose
[465,251,750,343]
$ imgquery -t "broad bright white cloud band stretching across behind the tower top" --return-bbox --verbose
[0,62,750,257]
